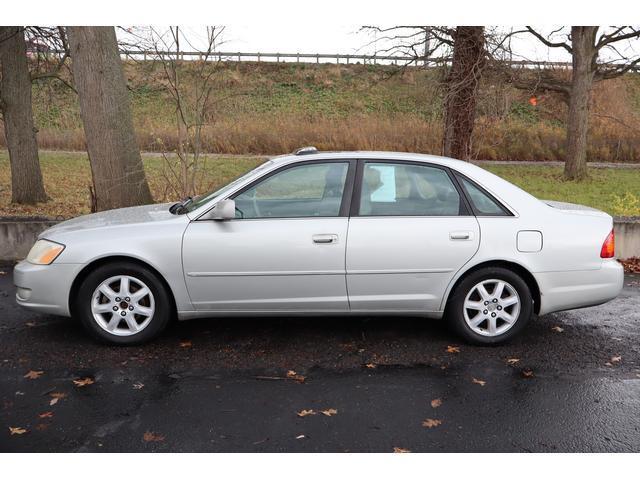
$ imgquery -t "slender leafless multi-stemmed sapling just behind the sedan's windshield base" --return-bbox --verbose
[137,26,224,198]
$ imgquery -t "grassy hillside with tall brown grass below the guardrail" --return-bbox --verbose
[7,62,640,162]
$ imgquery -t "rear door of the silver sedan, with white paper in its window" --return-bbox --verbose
[346,160,480,313]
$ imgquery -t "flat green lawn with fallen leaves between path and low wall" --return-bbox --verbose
[0,151,640,218]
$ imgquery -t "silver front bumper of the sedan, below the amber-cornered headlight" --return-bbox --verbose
[13,260,82,317]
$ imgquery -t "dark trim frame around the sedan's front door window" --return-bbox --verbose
[220,158,356,221]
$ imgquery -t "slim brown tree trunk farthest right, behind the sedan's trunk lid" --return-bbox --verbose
[564,27,598,180]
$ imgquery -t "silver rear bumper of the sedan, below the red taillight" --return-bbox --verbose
[535,260,624,315]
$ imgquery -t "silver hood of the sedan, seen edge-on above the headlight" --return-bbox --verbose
[38,203,177,238]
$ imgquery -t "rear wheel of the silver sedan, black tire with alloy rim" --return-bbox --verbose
[446,267,533,345]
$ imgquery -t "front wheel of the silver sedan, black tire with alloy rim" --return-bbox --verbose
[73,261,173,345]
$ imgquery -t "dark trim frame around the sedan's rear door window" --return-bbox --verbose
[350,158,474,218]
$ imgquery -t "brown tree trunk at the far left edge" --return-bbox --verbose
[0,27,49,204]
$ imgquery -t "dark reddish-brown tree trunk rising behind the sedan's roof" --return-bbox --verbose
[442,27,484,160]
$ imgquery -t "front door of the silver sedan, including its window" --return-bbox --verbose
[183,160,355,312]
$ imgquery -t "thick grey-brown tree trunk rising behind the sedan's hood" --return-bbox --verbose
[67,27,153,210]
